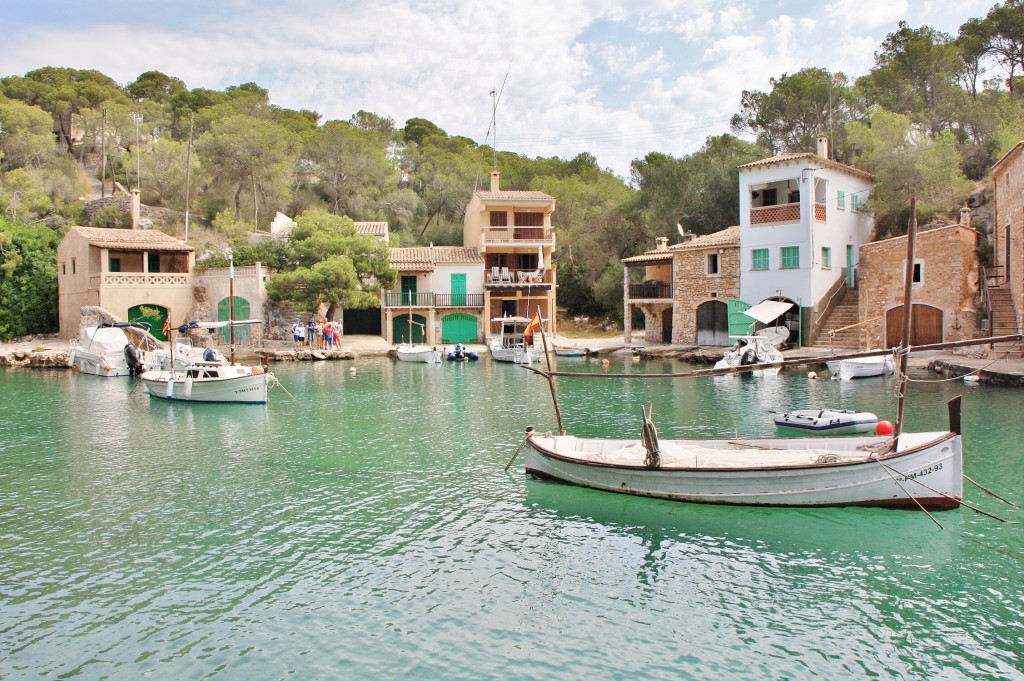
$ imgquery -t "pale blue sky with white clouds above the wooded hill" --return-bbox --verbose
[0,0,994,179]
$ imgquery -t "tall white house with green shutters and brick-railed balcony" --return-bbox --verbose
[738,136,874,345]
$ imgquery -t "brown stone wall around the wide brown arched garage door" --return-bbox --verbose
[858,225,978,347]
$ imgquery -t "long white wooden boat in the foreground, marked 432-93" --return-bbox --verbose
[525,421,963,509]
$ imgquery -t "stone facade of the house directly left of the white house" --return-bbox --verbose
[672,246,739,345]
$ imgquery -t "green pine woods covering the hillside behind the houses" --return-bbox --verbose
[0,0,1024,335]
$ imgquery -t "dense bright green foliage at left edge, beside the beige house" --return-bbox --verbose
[0,218,58,341]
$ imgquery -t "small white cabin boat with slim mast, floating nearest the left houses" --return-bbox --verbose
[140,361,274,405]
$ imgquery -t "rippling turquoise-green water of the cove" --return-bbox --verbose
[0,359,1024,679]
